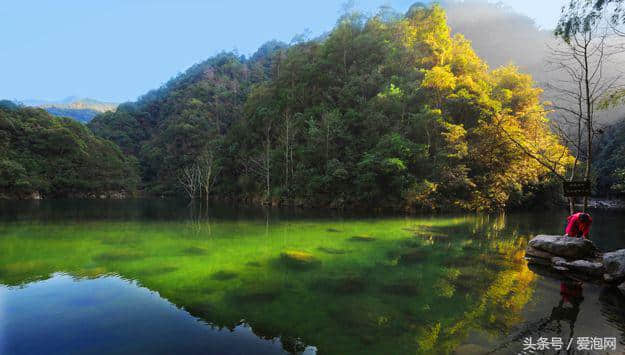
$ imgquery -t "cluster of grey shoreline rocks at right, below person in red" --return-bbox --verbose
[525,235,625,295]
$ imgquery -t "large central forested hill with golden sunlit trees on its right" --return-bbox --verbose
[89,6,570,210]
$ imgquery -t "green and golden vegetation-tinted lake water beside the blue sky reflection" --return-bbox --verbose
[0,213,535,354]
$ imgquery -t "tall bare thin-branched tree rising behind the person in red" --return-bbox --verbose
[547,13,622,213]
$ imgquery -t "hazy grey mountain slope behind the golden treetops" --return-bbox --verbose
[441,0,625,124]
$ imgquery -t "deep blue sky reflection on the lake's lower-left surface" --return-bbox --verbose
[0,274,315,354]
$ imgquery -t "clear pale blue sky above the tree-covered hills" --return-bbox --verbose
[0,0,564,102]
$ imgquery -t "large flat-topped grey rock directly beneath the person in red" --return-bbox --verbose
[529,235,598,260]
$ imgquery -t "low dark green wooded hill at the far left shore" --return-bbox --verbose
[0,101,138,198]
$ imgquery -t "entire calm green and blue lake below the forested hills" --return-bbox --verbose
[0,200,625,354]
